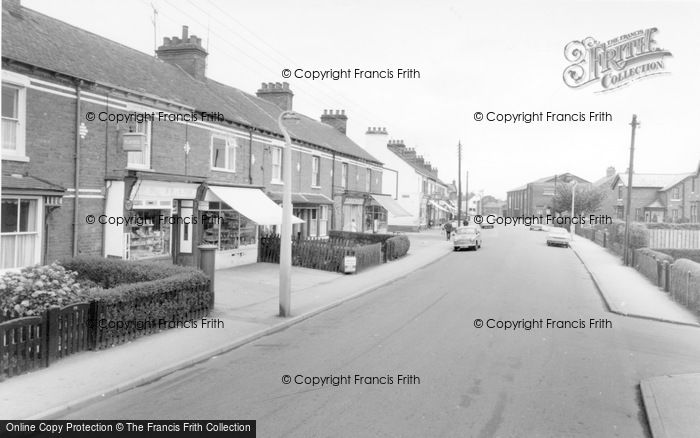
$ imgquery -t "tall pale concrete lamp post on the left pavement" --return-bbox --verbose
[277,111,299,317]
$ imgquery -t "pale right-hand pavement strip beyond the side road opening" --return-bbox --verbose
[571,236,700,326]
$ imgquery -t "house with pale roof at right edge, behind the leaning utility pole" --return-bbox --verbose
[610,165,700,222]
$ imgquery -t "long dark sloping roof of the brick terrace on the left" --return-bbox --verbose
[2,2,381,164]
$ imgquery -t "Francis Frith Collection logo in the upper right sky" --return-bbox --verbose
[564,27,673,93]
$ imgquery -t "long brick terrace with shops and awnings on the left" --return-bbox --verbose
[0,0,386,270]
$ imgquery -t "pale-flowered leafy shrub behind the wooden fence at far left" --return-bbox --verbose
[0,263,87,321]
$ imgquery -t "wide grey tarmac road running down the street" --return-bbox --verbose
[66,226,700,437]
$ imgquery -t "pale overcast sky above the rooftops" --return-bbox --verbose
[22,0,700,199]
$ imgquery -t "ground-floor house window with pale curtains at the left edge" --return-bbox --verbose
[0,197,41,269]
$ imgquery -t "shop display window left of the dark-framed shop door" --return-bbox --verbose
[128,209,172,260]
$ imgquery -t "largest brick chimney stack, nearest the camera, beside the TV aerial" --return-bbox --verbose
[156,26,208,80]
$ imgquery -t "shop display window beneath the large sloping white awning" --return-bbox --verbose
[202,202,257,251]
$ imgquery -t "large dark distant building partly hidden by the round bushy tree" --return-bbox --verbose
[506,172,591,217]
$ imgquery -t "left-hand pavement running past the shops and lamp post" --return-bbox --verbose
[0,230,452,420]
